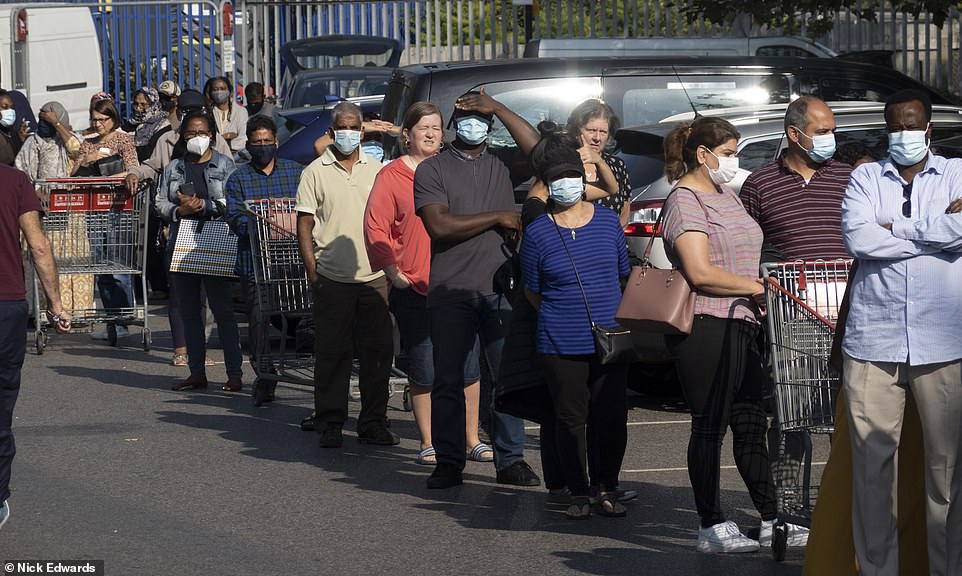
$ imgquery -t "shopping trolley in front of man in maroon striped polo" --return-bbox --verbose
[762,260,851,560]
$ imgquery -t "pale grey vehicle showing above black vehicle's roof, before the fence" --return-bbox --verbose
[524,36,838,58]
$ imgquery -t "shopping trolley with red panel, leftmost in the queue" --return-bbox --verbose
[33,178,151,354]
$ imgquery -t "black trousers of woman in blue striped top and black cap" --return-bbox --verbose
[541,354,628,496]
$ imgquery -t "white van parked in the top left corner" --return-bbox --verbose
[0,4,103,129]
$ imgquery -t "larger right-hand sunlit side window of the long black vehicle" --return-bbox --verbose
[605,74,792,126]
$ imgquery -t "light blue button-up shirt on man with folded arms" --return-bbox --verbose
[842,153,962,366]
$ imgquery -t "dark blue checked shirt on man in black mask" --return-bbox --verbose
[226,158,304,281]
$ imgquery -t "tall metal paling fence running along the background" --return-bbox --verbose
[9,0,962,108]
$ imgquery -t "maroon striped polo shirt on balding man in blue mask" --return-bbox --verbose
[740,154,852,260]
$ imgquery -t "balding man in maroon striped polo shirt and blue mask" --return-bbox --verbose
[740,96,852,262]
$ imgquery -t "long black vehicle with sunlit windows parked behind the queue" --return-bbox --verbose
[381,56,954,197]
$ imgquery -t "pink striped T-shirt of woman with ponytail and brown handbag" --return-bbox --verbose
[662,186,762,323]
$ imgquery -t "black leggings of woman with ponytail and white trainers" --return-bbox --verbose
[668,315,776,528]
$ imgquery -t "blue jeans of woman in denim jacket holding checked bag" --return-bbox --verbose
[170,273,243,378]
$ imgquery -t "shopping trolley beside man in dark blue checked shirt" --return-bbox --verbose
[246,198,407,406]
